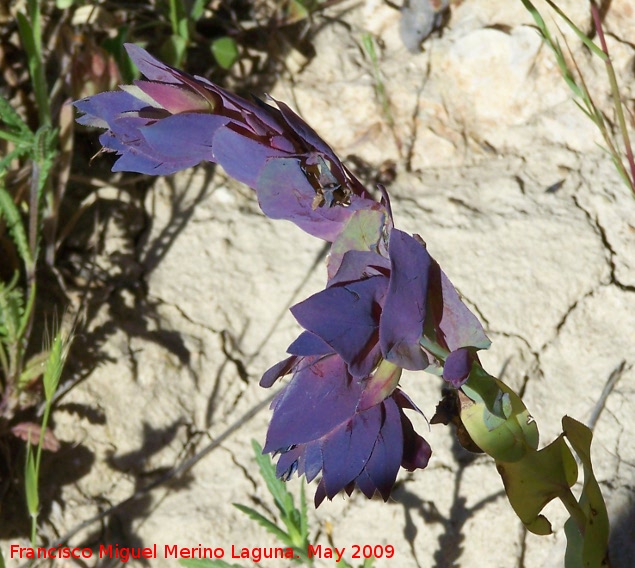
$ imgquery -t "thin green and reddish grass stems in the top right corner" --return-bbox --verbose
[521,0,635,196]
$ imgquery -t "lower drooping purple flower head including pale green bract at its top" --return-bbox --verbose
[260,211,489,505]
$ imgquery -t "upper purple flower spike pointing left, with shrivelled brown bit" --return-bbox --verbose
[75,44,384,241]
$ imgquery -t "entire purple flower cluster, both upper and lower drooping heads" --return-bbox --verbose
[75,45,489,505]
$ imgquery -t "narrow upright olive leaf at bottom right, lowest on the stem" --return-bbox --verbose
[562,416,609,568]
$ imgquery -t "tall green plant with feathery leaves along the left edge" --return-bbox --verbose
[0,0,70,544]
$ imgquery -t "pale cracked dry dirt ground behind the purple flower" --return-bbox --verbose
[3,0,635,568]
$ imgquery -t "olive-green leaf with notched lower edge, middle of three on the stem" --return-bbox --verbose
[496,434,578,535]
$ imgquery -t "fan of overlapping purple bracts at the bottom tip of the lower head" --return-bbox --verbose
[263,354,430,506]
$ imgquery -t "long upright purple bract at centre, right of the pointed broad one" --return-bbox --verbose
[379,229,432,371]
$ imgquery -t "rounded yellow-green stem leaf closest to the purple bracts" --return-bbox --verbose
[461,364,538,462]
